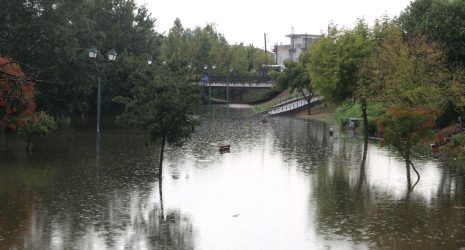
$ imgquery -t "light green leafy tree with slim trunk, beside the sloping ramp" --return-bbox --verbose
[308,20,376,140]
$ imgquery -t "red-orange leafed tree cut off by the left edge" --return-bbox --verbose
[0,56,36,132]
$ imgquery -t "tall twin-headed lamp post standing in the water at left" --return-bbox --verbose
[89,46,117,153]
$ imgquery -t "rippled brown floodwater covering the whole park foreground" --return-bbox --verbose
[0,107,465,250]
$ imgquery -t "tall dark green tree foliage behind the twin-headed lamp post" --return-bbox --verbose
[0,0,160,115]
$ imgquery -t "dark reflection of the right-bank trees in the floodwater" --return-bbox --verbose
[272,118,465,249]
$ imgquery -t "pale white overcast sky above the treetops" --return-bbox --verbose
[137,0,410,48]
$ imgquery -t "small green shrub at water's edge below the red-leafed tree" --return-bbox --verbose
[19,111,57,137]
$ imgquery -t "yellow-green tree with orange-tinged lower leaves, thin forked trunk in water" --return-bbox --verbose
[371,25,451,189]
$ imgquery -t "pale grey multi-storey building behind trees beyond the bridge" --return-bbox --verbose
[273,34,319,65]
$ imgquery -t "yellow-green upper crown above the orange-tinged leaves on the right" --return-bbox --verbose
[371,26,450,112]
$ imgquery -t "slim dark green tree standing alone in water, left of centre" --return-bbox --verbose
[120,63,200,178]
